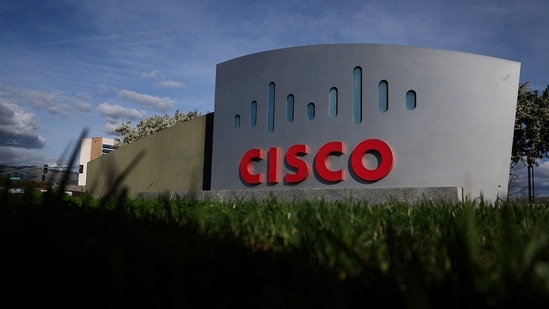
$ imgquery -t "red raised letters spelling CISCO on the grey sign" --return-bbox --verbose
[240,139,394,185]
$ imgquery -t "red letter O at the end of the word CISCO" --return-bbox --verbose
[351,139,393,181]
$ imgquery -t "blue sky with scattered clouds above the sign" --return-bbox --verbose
[0,0,549,195]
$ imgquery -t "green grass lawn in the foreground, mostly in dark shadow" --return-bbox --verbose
[0,186,549,308]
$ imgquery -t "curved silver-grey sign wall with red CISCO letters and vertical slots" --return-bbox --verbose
[211,44,520,197]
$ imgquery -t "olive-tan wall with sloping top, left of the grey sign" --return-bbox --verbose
[86,113,213,197]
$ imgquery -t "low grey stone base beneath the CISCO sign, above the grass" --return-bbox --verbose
[185,187,463,204]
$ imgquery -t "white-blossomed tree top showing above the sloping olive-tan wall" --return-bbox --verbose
[114,109,200,147]
